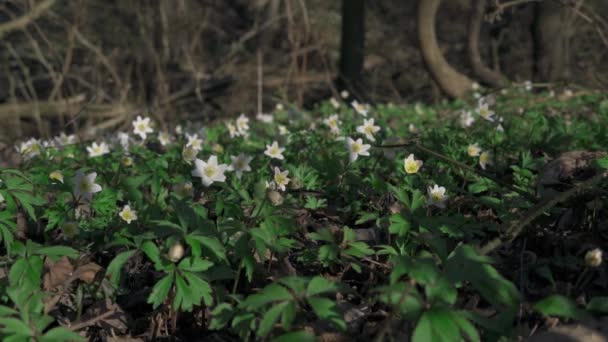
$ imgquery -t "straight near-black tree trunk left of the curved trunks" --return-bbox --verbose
[338,0,365,95]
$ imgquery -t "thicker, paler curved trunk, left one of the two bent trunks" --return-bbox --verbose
[418,0,473,98]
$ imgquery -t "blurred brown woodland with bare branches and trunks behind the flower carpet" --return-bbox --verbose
[0,0,608,144]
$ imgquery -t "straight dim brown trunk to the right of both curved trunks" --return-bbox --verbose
[534,0,568,82]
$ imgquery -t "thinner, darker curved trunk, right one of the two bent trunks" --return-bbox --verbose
[467,0,508,87]
